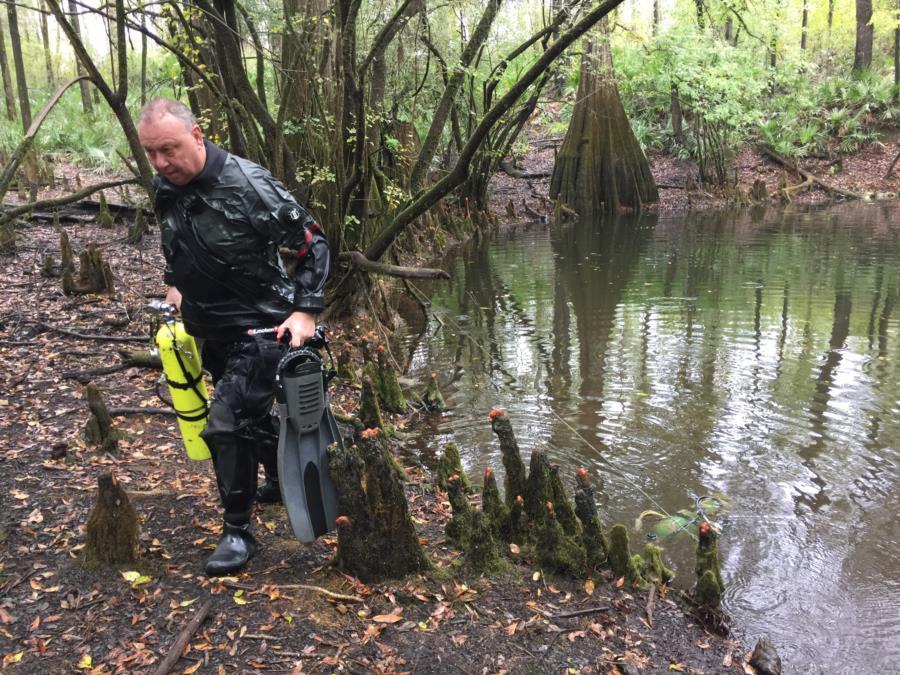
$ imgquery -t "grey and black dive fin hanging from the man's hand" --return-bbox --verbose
[277,349,341,543]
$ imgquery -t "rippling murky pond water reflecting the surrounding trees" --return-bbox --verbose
[408,204,900,673]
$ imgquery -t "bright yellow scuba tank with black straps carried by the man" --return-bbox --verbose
[154,308,210,460]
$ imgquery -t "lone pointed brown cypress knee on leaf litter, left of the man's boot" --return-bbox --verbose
[83,473,140,567]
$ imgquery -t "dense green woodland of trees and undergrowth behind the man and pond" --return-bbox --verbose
[0,0,900,282]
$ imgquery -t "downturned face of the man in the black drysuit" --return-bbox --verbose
[138,114,206,185]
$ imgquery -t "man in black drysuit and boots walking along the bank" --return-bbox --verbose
[138,99,330,576]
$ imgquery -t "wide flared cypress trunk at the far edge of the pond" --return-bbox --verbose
[550,19,659,216]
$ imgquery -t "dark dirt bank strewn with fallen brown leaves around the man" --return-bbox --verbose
[0,215,747,673]
